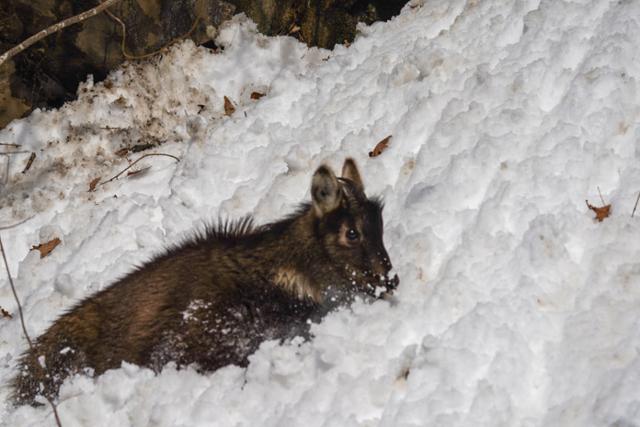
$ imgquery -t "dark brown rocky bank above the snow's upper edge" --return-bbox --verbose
[0,0,405,128]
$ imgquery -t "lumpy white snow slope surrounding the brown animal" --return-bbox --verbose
[0,0,640,427]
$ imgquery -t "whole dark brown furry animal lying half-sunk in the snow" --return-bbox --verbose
[13,159,398,404]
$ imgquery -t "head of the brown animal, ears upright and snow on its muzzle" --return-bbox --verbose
[311,159,398,302]
